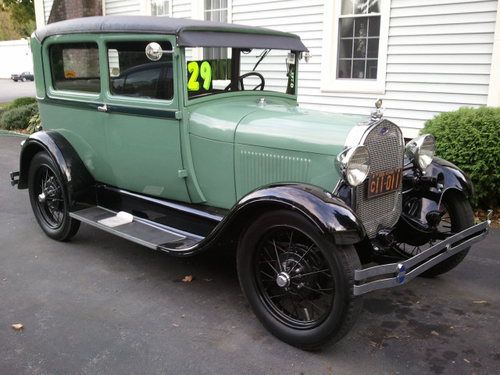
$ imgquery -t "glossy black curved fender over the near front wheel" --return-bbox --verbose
[216,183,366,245]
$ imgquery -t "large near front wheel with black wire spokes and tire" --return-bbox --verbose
[237,210,362,350]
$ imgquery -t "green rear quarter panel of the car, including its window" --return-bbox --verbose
[39,35,110,181]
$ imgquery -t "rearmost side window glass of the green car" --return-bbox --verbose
[49,43,101,93]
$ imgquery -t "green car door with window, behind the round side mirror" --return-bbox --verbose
[100,35,189,201]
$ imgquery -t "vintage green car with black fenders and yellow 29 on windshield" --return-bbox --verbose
[11,16,489,349]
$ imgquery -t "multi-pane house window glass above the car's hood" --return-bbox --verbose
[337,0,381,79]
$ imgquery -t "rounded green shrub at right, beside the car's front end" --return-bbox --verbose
[422,107,500,208]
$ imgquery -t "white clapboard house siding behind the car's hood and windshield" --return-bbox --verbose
[233,0,497,136]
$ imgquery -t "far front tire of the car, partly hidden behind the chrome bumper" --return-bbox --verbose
[422,192,474,277]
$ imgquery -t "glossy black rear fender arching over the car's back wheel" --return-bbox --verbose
[17,131,94,209]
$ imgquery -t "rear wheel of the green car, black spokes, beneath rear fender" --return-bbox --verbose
[28,152,80,241]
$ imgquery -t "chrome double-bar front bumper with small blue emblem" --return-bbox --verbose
[354,219,491,296]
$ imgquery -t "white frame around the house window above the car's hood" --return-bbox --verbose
[321,0,391,94]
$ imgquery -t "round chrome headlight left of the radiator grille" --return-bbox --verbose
[337,146,370,186]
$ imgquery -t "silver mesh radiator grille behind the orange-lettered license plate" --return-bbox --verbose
[355,120,404,238]
